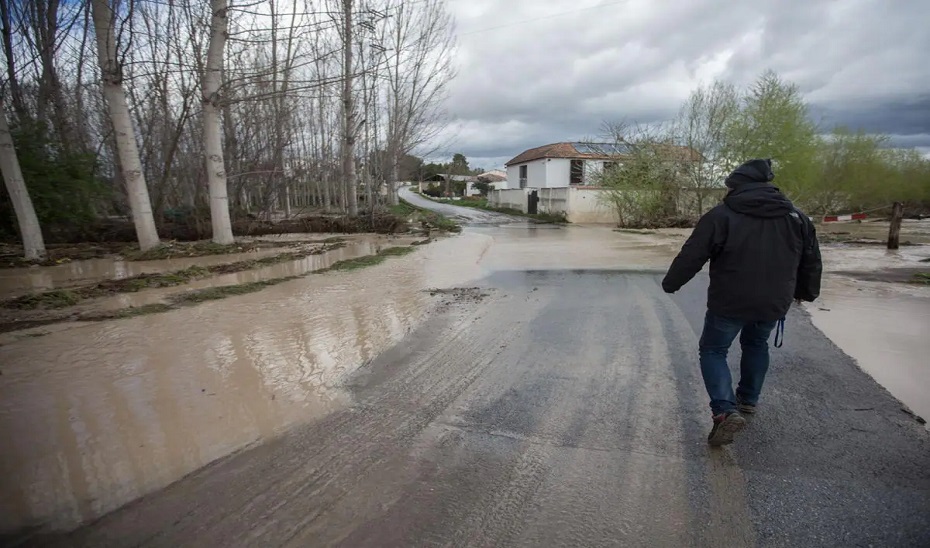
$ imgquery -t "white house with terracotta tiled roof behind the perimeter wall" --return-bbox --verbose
[505,142,628,188]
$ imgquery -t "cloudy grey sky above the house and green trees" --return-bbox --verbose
[438,0,930,169]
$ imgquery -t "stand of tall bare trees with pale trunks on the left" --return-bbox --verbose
[0,0,455,258]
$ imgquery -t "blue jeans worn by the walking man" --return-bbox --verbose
[700,310,778,415]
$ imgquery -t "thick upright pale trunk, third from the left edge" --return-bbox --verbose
[202,0,235,244]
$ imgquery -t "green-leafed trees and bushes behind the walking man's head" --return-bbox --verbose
[599,71,930,226]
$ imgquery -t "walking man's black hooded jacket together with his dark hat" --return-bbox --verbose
[662,160,822,321]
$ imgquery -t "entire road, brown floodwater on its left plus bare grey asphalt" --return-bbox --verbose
[0,202,930,547]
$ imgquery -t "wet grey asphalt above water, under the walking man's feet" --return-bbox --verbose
[25,202,930,547]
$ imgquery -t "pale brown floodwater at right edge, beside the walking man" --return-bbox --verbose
[806,276,930,419]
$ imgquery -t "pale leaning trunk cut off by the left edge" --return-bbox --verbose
[0,107,45,261]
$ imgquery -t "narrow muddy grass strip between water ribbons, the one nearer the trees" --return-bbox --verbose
[0,243,345,310]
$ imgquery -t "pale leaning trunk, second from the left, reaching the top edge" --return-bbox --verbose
[91,0,159,250]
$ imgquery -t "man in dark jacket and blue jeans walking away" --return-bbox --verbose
[662,159,822,445]
